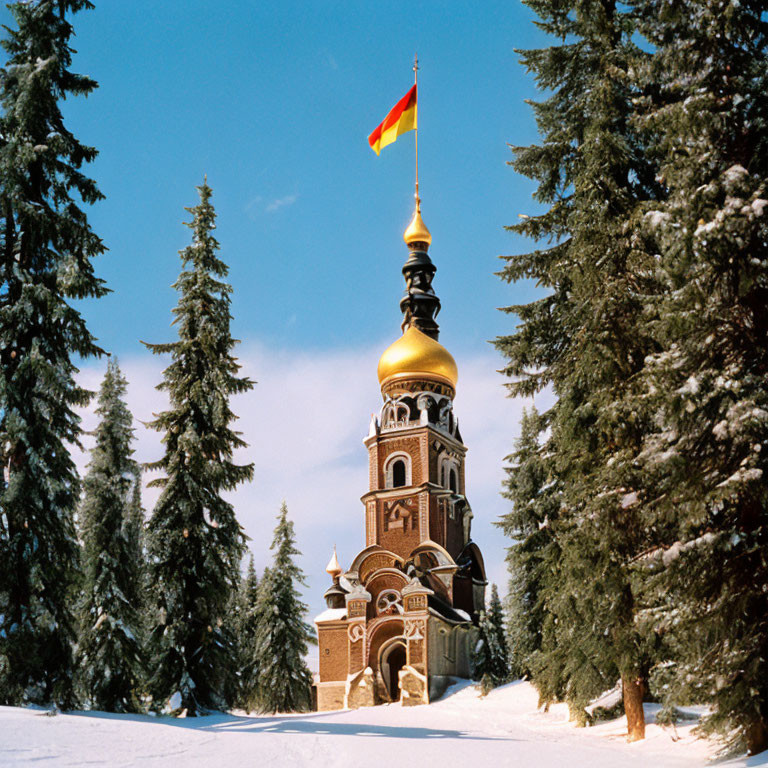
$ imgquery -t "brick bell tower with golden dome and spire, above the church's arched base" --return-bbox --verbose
[362,205,472,558]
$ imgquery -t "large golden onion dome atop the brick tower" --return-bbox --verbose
[378,325,459,389]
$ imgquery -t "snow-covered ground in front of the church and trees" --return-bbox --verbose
[0,683,768,768]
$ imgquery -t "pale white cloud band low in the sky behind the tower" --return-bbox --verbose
[70,343,550,615]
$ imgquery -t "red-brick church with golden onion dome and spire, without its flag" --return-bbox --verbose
[315,197,486,711]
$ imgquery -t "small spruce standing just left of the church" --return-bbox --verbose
[254,502,314,712]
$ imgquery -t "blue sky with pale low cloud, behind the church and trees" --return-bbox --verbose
[0,0,546,624]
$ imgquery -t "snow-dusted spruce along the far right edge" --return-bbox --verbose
[635,0,768,753]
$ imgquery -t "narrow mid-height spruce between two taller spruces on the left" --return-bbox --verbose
[78,359,144,712]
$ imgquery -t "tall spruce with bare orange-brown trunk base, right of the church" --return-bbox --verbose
[497,0,659,739]
